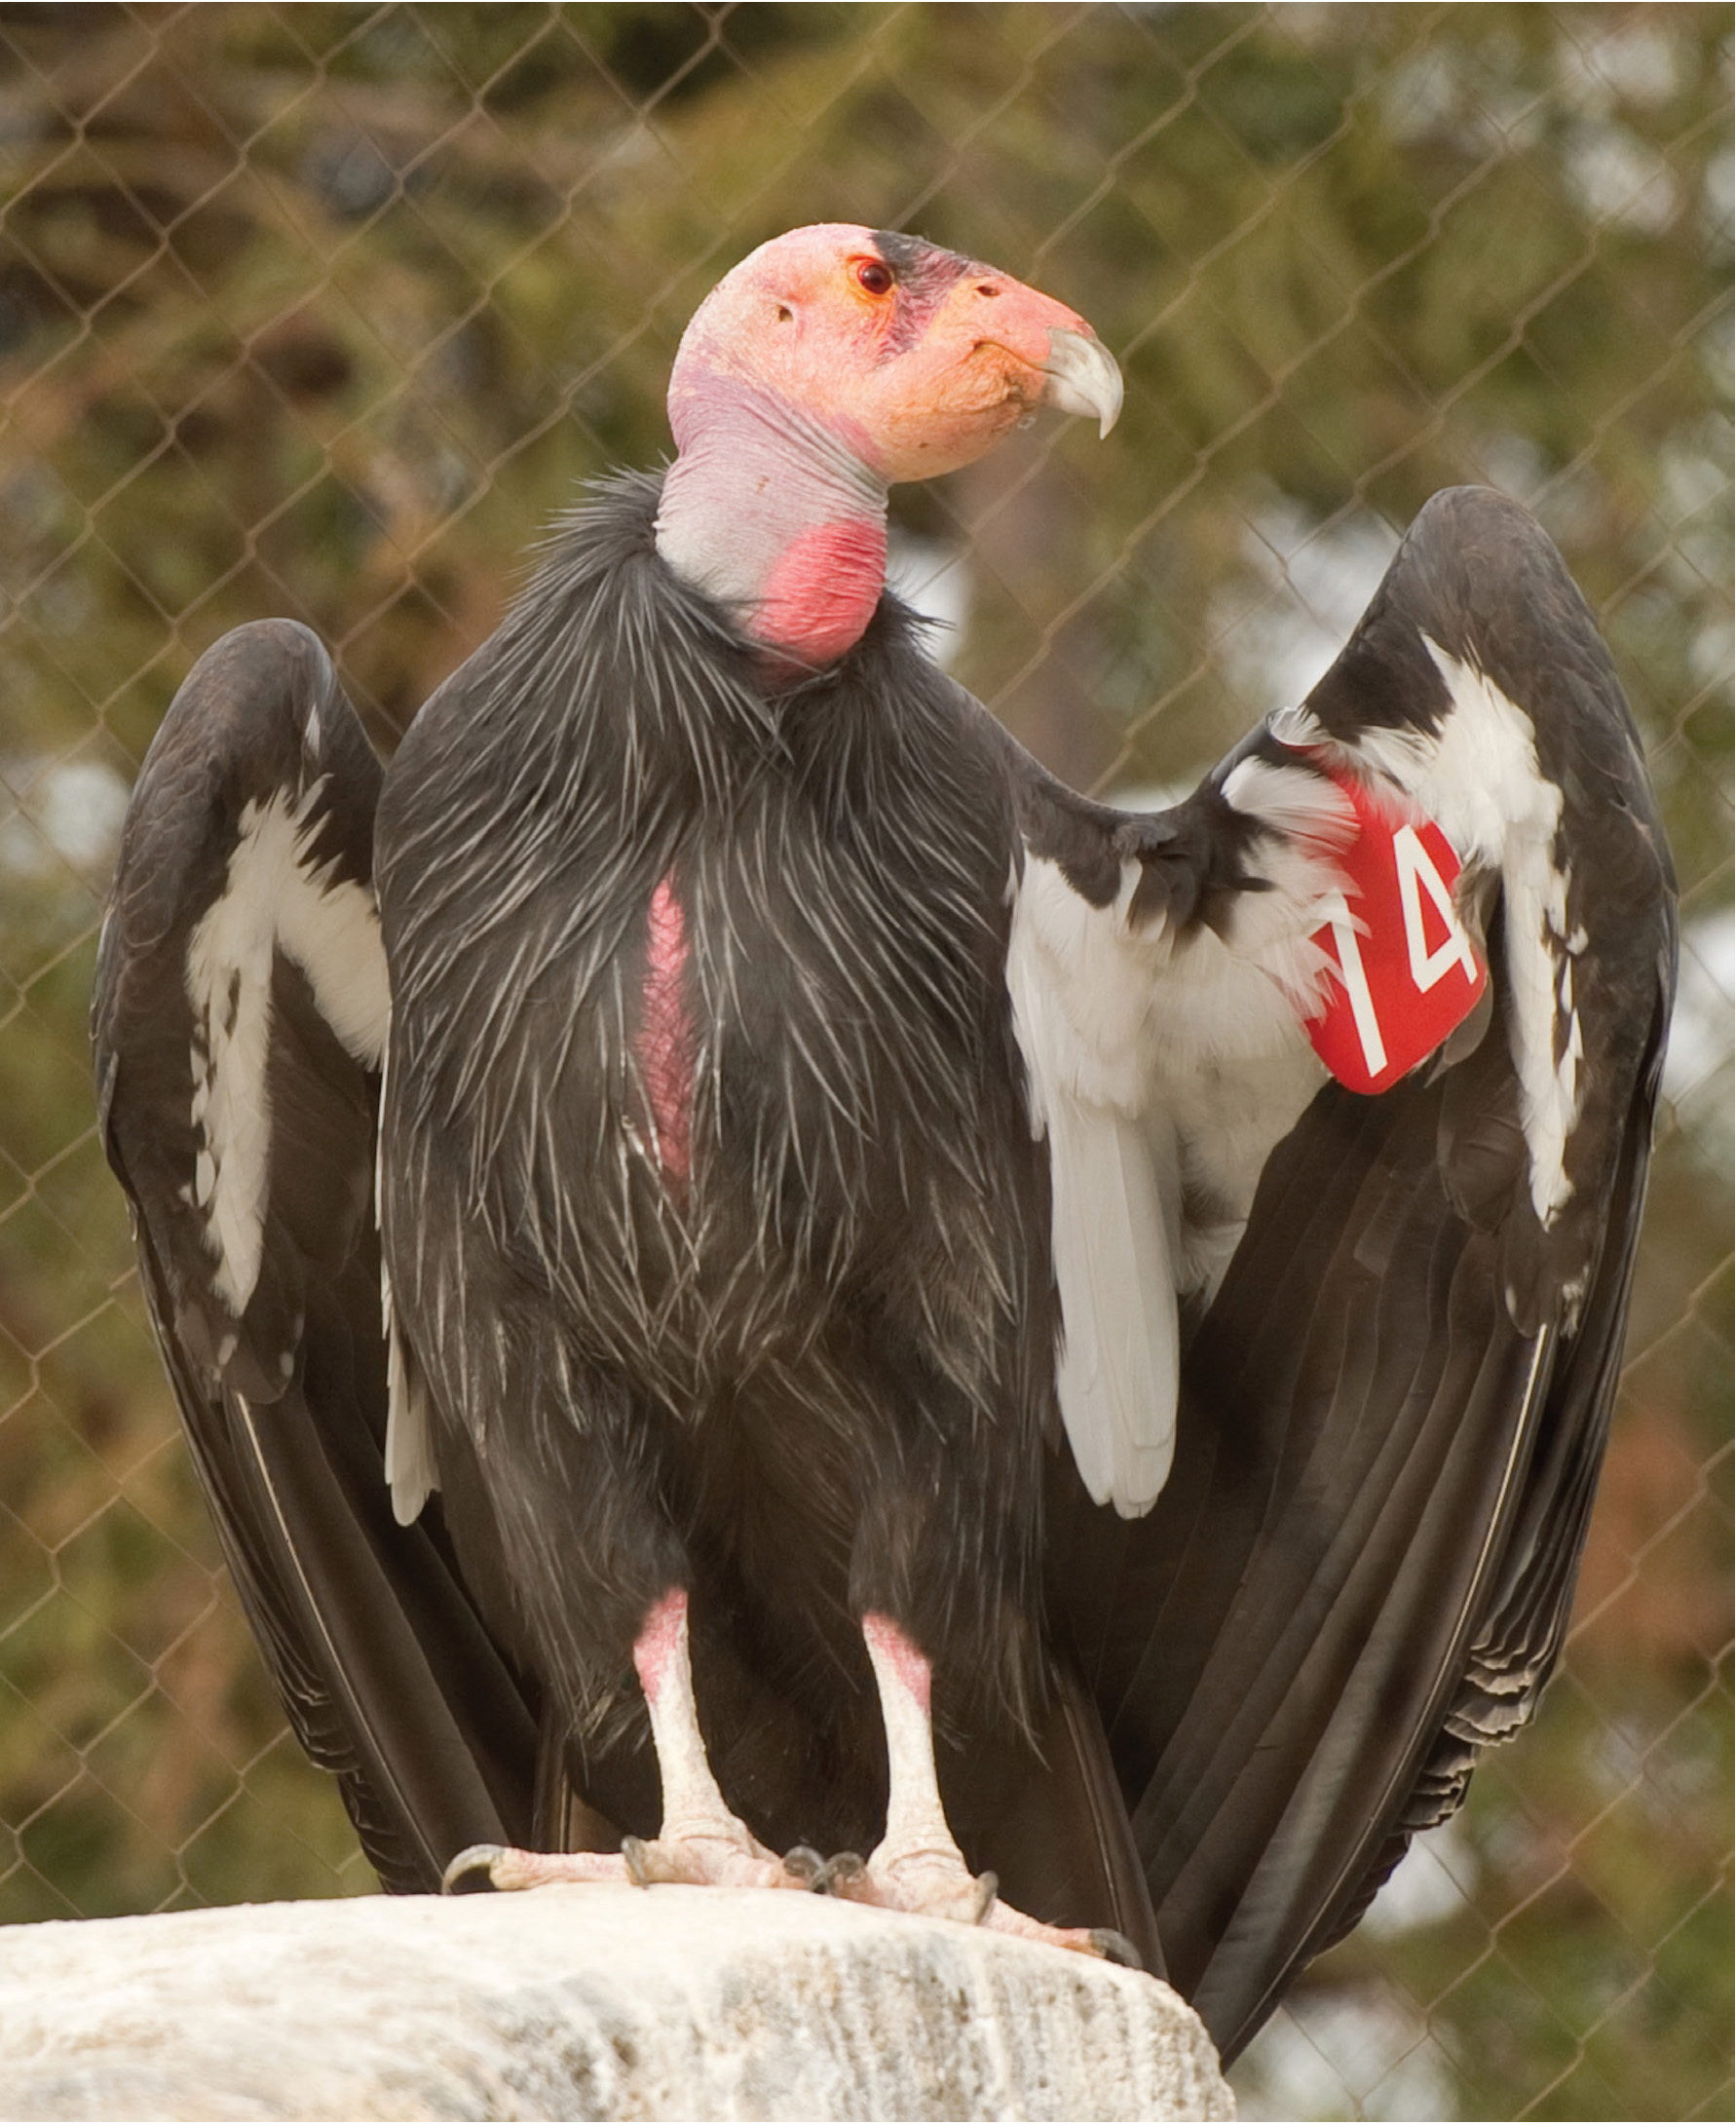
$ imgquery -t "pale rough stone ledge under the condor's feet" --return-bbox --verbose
[0,1887,1234,2118]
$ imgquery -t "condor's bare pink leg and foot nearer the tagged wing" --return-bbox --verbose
[820,1615,1139,1965]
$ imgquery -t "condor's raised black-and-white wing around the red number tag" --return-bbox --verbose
[1009,489,1675,2055]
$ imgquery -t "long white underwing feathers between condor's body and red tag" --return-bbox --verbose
[1007,828,1345,1517]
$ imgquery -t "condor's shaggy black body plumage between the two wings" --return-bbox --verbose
[378,482,1071,1848]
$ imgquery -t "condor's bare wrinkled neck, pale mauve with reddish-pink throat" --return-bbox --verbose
[657,372,887,667]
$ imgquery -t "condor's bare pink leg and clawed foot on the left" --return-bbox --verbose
[442,1587,803,1889]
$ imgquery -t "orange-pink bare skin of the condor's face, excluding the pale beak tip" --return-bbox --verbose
[669,223,1090,486]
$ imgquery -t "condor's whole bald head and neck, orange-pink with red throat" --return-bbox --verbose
[657,223,1119,663]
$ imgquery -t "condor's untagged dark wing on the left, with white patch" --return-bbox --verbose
[94,621,536,1889]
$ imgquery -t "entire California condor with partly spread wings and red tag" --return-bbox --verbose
[95,227,1675,2055]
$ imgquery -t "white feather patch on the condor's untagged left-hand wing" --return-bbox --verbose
[185,784,389,1319]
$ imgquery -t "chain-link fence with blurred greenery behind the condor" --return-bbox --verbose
[0,4,1732,2116]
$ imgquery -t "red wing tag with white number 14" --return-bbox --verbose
[1309,770,1490,1092]
